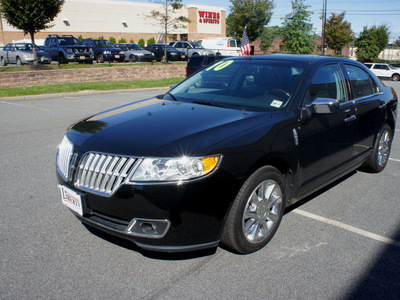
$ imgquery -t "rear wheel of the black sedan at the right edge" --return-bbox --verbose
[364,124,393,173]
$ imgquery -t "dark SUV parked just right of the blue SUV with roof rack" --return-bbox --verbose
[82,39,125,63]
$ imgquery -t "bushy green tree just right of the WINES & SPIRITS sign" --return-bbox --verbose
[226,0,274,42]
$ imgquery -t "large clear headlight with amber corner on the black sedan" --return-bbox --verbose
[129,155,221,183]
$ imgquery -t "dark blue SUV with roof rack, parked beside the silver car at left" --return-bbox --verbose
[44,34,94,64]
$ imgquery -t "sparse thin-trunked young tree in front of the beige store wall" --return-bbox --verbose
[147,0,190,62]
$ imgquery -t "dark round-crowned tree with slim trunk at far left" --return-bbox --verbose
[0,0,64,65]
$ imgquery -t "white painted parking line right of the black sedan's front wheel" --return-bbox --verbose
[293,209,400,248]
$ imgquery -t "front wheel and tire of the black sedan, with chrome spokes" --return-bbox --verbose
[221,166,286,254]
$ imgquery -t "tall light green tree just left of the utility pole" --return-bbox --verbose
[283,0,314,54]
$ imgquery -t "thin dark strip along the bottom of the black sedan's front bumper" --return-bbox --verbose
[82,223,217,260]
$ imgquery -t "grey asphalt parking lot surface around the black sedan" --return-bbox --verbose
[0,81,400,299]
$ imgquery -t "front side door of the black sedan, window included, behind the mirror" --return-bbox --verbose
[298,64,356,195]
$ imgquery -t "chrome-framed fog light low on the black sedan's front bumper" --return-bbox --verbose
[125,218,171,239]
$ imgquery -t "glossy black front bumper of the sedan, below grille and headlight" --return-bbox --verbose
[57,173,240,252]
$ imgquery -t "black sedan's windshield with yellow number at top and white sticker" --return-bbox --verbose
[170,59,304,111]
